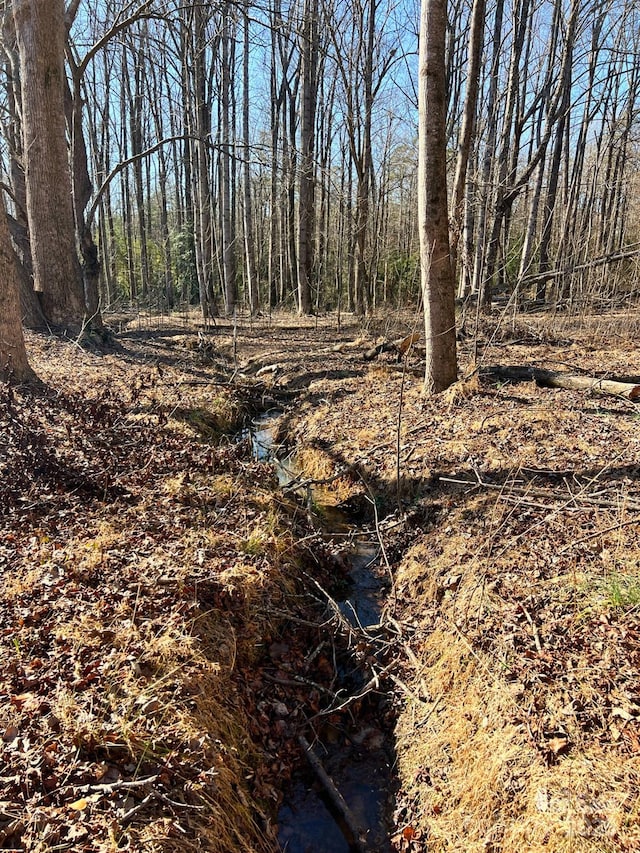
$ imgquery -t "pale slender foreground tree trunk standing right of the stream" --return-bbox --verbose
[418,0,457,393]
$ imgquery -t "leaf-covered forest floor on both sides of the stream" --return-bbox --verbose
[0,313,640,853]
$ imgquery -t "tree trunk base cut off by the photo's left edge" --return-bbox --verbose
[0,198,35,382]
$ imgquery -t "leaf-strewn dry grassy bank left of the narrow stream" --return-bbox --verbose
[0,336,310,853]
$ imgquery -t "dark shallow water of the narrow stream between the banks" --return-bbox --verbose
[249,412,393,853]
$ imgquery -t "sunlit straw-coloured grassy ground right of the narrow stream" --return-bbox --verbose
[282,313,640,853]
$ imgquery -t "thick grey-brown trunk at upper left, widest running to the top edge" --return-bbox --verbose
[13,0,84,326]
